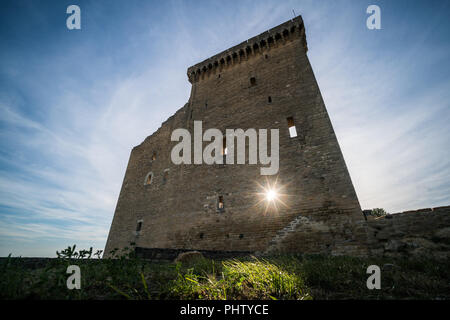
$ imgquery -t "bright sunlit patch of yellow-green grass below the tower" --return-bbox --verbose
[171,258,310,300]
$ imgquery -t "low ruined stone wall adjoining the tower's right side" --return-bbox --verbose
[367,206,450,258]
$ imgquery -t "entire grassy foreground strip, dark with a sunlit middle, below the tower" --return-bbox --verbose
[0,248,450,300]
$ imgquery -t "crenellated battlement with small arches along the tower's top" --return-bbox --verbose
[187,16,308,83]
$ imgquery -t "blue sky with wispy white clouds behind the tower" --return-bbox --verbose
[0,0,450,256]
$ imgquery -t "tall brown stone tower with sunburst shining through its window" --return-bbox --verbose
[105,16,366,256]
